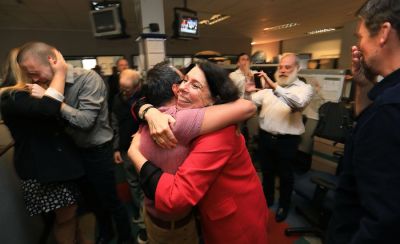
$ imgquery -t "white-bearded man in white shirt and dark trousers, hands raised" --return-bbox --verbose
[251,53,313,222]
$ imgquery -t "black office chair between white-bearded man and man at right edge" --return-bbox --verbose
[285,102,353,240]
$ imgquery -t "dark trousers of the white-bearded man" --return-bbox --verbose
[259,129,300,209]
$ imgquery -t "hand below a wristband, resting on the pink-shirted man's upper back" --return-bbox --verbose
[145,109,178,149]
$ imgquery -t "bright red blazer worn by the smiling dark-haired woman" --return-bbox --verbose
[155,126,268,244]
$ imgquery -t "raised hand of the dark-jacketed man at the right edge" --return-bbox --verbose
[351,46,376,86]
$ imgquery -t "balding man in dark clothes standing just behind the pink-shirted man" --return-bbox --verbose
[111,69,147,243]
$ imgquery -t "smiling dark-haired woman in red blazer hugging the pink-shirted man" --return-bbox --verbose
[129,59,268,244]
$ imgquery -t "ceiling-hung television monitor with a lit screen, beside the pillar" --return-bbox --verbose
[174,8,199,39]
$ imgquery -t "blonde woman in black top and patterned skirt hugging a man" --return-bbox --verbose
[0,49,84,243]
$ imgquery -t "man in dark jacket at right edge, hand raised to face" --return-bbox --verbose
[327,0,400,244]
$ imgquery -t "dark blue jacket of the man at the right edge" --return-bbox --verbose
[327,69,400,244]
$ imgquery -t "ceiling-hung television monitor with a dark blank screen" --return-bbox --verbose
[90,6,125,38]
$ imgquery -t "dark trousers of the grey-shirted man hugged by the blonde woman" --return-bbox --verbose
[81,142,131,240]
